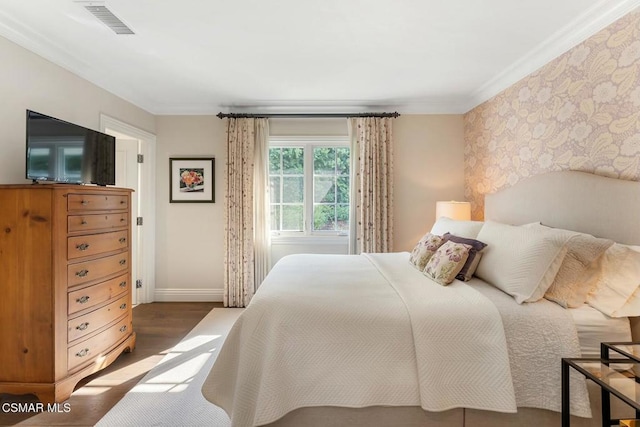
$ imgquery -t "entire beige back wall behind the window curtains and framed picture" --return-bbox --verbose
[156,115,464,301]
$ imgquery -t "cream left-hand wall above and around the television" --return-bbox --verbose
[0,37,156,184]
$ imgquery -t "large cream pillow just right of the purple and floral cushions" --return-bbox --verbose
[476,221,567,304]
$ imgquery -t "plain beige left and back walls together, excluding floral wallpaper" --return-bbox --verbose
[0,33,464,301]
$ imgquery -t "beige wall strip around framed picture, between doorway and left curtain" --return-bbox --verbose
[155,116,226,301]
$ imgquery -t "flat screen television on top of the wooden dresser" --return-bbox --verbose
[26,110,116,185]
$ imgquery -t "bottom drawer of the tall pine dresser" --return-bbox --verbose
[67,315,133,371]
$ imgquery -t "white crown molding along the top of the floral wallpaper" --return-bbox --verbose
[464,0,640,112]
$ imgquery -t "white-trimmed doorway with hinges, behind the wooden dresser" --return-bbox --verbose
[100,114,155,304]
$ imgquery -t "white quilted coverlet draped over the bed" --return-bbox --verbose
[202,253,588,426]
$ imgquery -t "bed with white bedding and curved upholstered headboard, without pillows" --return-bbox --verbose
[203,172,640,427]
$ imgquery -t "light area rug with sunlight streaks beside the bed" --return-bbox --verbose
[97,308,242,427]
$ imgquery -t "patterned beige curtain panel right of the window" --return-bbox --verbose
[349,117,393,254]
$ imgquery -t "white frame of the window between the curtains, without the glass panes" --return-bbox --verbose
[269,135,353,239]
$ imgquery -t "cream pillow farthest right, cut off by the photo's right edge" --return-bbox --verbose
[587,243,640,317]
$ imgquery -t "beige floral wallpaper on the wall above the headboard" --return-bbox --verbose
[464,9,640,219]
